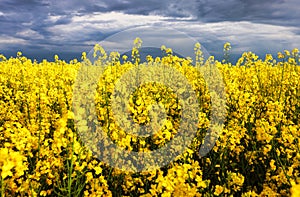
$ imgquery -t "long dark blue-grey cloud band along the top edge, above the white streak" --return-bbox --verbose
[67,0,300,26]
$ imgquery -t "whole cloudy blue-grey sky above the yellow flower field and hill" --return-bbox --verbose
[0,0,300,60]
